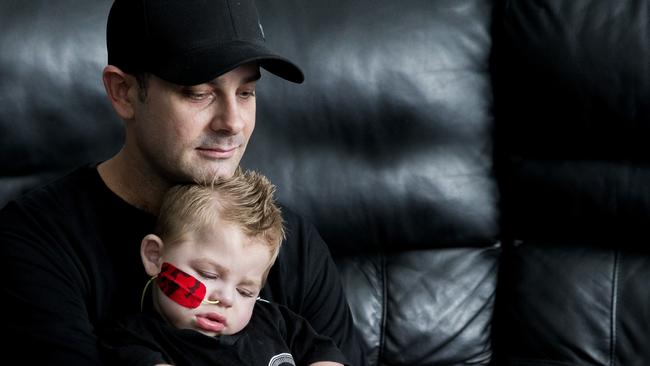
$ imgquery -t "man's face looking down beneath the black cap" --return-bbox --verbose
[126,64,260,184]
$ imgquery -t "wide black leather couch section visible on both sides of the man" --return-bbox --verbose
[0,0,499,365]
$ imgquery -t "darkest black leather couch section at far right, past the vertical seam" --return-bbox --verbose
[493,0,650,366]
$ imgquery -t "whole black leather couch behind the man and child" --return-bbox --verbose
[0,0,650,366]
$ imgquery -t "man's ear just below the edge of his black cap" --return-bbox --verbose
[102,65,138,120]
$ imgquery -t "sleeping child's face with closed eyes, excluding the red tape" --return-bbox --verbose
[154,222,271,336]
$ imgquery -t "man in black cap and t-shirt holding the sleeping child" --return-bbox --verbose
[0,0,363,365]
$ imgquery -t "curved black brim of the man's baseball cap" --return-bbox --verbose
[150,41,305,85]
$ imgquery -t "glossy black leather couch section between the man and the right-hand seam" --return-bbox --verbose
[245,0,499,366]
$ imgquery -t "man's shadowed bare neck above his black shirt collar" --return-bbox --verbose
[97,150,169,215]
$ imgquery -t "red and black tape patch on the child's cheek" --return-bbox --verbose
[157,262,205,309]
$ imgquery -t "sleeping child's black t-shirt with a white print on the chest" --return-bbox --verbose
[101,301,347,366]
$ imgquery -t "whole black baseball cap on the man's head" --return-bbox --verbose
[106,0,304,85]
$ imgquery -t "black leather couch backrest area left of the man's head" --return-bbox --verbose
[0,0,122,206]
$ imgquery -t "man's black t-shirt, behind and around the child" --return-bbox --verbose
[0,166,363,366]
